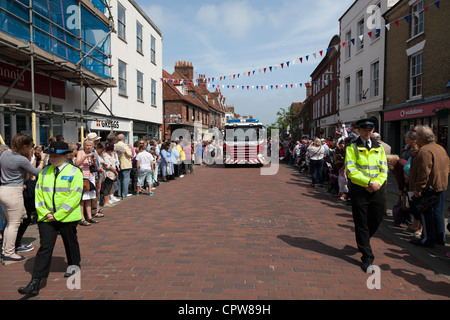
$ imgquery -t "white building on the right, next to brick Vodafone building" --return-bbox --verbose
[339,0,396,132]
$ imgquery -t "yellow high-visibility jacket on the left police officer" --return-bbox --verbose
[35,164,83,222]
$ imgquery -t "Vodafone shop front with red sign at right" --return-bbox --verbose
[384,100,450,154]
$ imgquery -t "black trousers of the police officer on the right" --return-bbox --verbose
[350,184,385,263]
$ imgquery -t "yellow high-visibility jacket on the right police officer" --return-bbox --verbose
[345,137,388,187]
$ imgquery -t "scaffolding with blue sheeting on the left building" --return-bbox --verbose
[0,0,116,143]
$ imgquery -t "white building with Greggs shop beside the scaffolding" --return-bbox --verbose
[83,0,163,143]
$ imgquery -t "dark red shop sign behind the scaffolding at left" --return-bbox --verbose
[0,62,66,99]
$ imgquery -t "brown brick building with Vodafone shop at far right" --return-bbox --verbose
[384,0,450,154]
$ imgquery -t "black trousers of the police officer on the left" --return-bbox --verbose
[32,221,81,279]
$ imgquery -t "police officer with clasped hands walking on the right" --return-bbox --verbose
[345,119,388,273]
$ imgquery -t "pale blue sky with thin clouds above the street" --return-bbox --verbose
[136,0,354,125]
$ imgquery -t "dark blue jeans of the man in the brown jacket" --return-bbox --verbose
[422,192,445,246]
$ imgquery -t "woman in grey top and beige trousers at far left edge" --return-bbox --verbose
[0,133,44,265]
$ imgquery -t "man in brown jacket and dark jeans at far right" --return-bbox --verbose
[409,125,449,248]
